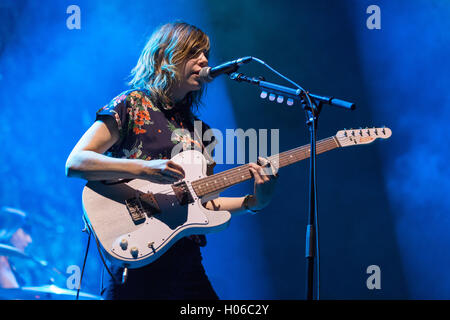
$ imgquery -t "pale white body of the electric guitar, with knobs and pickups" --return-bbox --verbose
[83,150,231,268]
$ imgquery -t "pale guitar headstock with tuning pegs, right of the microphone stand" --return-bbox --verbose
[336,127,392,147]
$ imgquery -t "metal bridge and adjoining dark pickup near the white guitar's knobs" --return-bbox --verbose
[125,192,161,224]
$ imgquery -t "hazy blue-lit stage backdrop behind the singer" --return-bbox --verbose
[0,0,450,299]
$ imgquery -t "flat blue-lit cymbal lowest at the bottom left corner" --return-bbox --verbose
[0,285,103,300]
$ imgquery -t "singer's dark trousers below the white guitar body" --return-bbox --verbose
[101,238,219,300]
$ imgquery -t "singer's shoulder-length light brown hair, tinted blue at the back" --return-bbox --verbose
[128,22,210,108]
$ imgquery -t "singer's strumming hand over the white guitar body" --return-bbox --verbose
[141,160,185,184]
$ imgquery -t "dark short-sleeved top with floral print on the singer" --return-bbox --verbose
[96,90,215,246]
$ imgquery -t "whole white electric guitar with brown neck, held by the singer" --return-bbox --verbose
[83,128,392,268]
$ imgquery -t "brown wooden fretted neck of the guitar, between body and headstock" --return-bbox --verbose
[191,136,340,197]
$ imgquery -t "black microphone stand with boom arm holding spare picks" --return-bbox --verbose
[230,73,355,300]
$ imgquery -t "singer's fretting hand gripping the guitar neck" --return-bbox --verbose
[248,157,278,210]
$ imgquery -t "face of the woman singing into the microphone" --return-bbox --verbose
[174,51,208,101]
